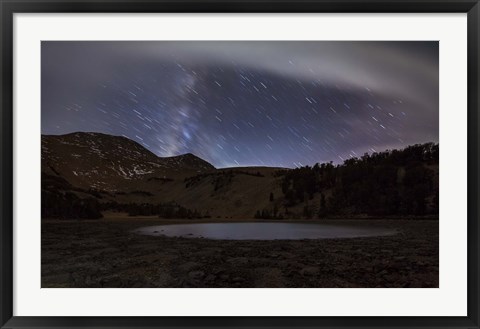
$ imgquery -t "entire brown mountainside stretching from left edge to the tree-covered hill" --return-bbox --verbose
[42,133,281,218]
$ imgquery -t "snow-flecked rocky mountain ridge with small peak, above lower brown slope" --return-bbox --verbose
[42,132,215,191]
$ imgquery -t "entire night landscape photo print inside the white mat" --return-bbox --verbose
[41,41,439,288]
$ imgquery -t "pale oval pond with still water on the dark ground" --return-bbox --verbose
[135,222,396,240]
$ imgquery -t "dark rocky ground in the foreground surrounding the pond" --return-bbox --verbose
[42,218,439,288]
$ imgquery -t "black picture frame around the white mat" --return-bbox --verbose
[0,0,480,329]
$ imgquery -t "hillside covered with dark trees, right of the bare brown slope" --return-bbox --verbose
[255,143,439,218]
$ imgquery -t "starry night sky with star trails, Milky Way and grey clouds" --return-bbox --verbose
[41,41,439,168]
